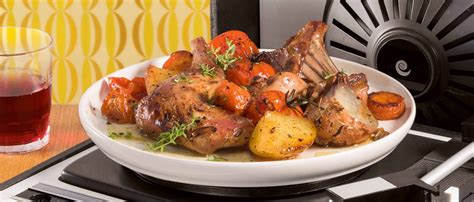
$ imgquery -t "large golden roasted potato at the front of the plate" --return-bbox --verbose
[249,111,316,159]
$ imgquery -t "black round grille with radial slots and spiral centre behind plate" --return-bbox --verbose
[324,0,474,131]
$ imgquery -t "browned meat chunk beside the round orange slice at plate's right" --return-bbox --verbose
[306,74,378,146]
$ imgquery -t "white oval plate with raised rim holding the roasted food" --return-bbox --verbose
[79,57,416,187]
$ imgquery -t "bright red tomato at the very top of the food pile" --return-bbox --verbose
[210,30,258,58]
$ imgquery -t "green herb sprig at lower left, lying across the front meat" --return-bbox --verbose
[147,118,200,152]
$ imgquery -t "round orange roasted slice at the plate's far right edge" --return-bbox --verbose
[367,91,405,120]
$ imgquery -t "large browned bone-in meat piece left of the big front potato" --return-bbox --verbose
[136,38,253,154]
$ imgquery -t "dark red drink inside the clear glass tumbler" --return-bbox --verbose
[0,71,51,146]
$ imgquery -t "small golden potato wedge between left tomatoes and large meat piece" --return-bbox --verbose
[145,65,180,95]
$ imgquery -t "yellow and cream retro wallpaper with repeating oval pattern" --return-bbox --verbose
[0,0,210,104]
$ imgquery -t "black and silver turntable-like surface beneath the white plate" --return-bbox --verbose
[0,130,474,201]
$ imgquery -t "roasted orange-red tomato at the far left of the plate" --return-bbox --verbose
[101,77,146,124]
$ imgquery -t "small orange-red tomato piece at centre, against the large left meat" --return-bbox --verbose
[216,80,251,115]
